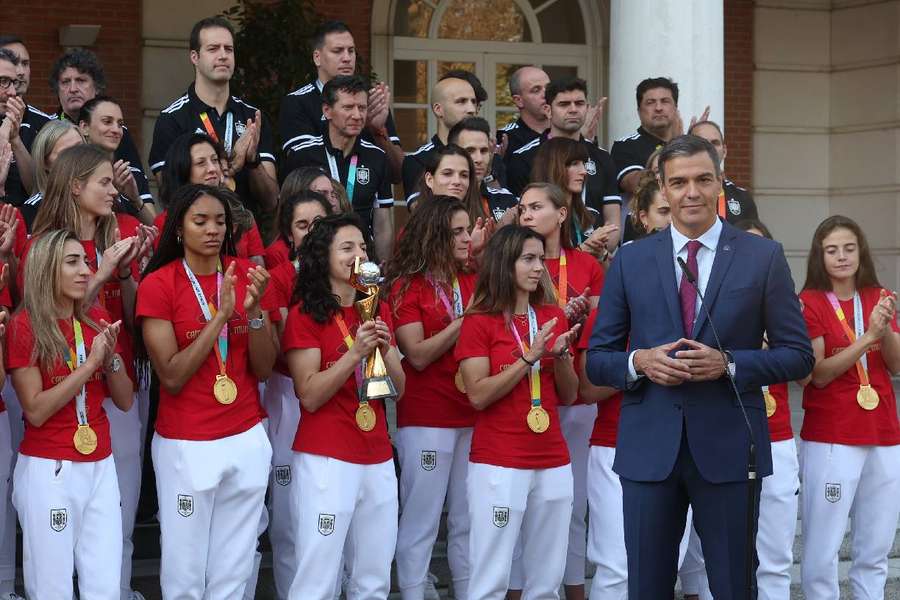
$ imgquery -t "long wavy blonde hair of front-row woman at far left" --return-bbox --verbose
[17,230,100,369]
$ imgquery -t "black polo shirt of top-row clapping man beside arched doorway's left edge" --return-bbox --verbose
[278,80,400,152]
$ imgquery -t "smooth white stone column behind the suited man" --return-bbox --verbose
[608,0,727,142]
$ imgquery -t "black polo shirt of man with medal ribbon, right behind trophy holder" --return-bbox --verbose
[284,135,394,237]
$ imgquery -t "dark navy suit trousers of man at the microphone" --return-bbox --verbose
[621,436,755,600]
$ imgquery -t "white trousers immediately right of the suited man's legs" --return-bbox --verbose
[756,438,800,600]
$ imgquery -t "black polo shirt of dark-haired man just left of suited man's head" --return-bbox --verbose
[507,130,622,219]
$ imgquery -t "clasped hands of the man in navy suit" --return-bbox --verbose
[634,338,728,386]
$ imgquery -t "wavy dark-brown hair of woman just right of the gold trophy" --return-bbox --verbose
[383,196,466,314]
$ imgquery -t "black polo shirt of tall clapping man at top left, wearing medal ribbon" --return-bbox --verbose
[150,83,275,210]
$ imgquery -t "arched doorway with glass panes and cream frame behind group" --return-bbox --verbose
[372,0,609,151]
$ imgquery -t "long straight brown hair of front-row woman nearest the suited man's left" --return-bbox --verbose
[469,225,556,314]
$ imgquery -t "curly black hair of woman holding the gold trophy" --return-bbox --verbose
[291,213,365,324]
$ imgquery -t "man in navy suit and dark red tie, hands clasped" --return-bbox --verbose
[587,136,814,600]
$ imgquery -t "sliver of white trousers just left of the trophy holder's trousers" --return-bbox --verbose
[264,372,300,598]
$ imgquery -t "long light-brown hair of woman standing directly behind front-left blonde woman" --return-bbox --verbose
[32,144,117,256]
